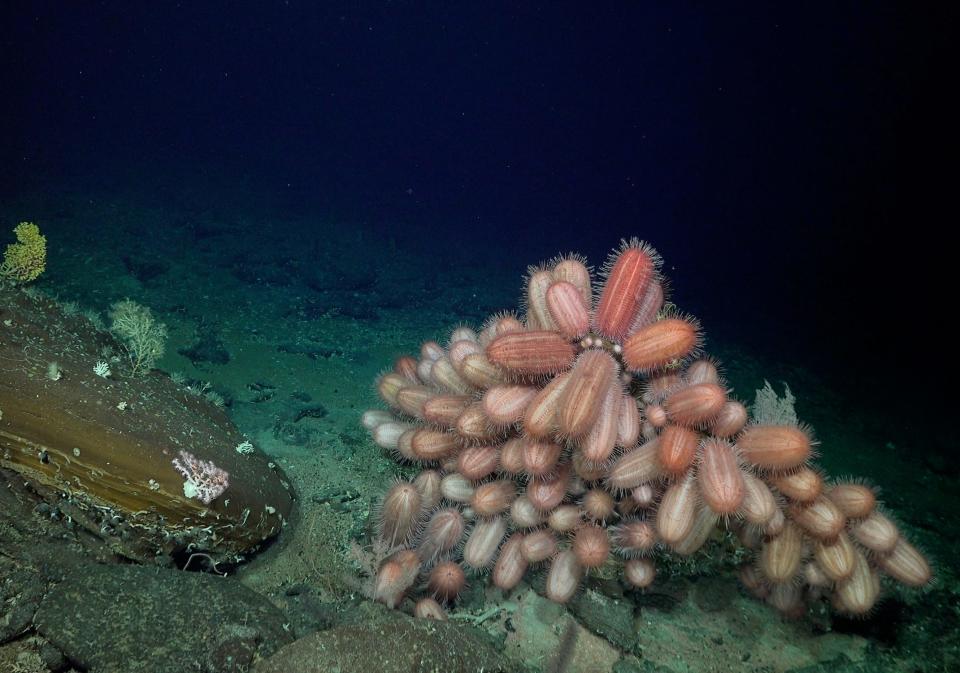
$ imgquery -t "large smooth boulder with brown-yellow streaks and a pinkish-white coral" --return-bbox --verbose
[0,287,293,560]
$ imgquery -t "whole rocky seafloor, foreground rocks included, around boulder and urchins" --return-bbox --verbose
[0,176,960,673]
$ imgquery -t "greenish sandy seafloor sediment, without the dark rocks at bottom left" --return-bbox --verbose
[0,176,960,673]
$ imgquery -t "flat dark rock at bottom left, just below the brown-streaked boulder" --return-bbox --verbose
[34,564,291,673]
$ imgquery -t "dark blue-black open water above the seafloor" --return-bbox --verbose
[0,1,957,436]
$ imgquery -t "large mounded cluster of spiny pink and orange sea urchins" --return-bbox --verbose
[363,241,931,618]
